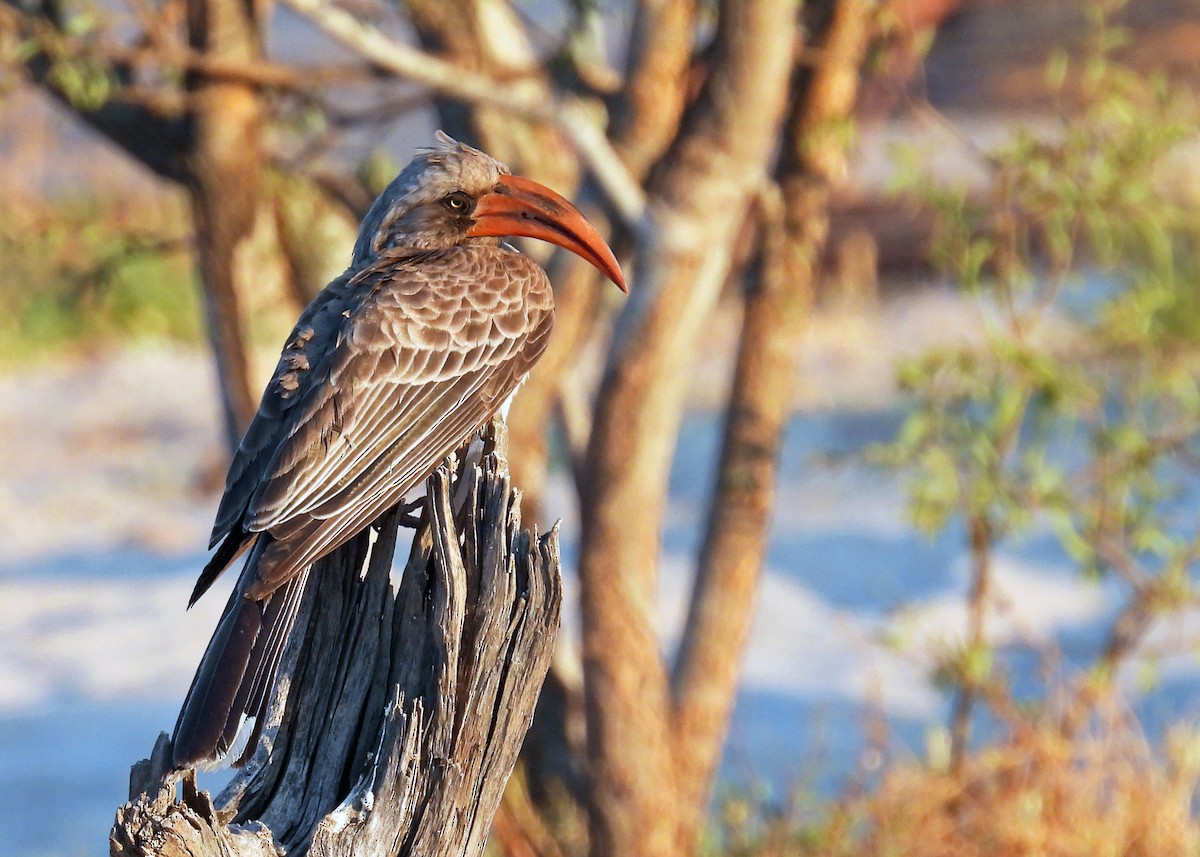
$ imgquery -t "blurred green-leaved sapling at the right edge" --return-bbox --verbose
[877,5,1200,739]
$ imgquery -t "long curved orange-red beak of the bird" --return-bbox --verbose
[467,175,629,292]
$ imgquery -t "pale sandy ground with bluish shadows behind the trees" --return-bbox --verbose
[0,289,1200,857]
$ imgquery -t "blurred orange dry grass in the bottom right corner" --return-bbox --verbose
[724,708,1200,857]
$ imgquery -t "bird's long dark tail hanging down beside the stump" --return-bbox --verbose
[172,537,308,769]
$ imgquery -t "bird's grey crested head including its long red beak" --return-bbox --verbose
[354,131,628,292]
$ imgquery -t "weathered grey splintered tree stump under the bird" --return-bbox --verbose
[110,441,562,857]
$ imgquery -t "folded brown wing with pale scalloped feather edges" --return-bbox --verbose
[210,248,553,598]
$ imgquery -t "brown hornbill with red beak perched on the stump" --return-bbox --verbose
[172,132,628,771]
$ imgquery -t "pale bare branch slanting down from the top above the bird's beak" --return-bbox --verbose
[276,0,646,229]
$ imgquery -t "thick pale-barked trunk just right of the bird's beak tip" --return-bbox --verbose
[581,0,797,856]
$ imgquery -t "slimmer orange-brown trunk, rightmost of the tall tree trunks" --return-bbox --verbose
[672,0,871,833]
